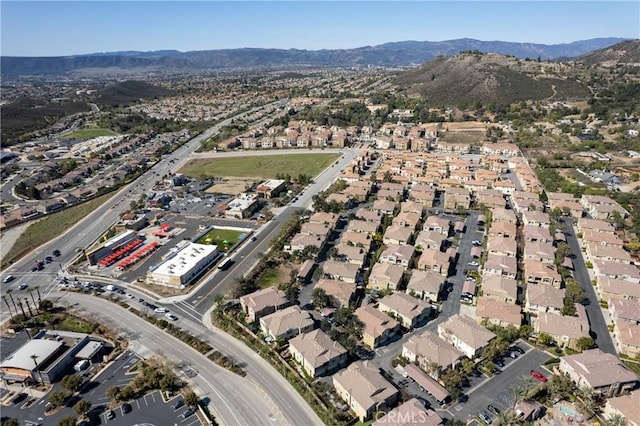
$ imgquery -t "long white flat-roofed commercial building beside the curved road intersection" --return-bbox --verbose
[147,241,220,287]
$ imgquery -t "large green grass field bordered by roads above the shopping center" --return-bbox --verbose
[180,154,340,179]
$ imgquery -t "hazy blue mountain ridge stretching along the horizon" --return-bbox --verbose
[0,37,628,79]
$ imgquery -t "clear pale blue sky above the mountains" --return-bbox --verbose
[0,0,640,56]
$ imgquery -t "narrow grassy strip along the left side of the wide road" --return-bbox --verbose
[2,193,114,268]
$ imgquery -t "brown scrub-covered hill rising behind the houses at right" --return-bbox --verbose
[396,52,589,105]
